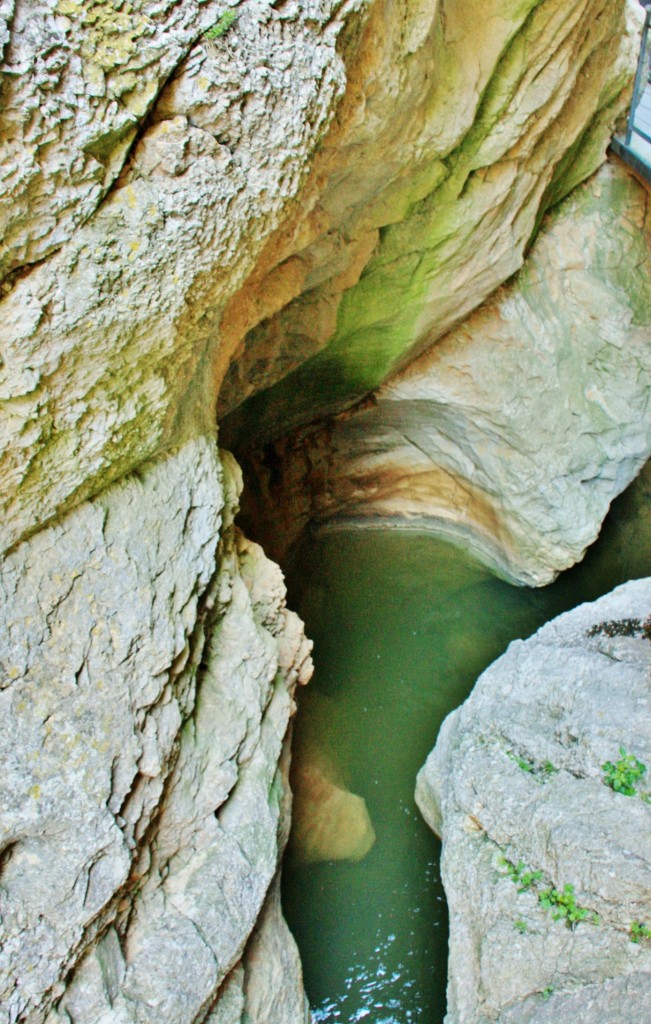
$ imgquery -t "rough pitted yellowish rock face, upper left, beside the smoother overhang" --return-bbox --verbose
[0,0,356,550]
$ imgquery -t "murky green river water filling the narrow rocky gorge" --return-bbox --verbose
[283,468,651,1024]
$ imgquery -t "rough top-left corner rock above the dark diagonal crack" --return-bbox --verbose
[0,0,231,279]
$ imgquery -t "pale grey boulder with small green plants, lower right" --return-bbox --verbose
[417,580,651,1024]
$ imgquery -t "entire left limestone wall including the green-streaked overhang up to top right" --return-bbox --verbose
[0,0,637,1024]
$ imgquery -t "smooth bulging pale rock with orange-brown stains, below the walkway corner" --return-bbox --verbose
[240,163,651,586]
